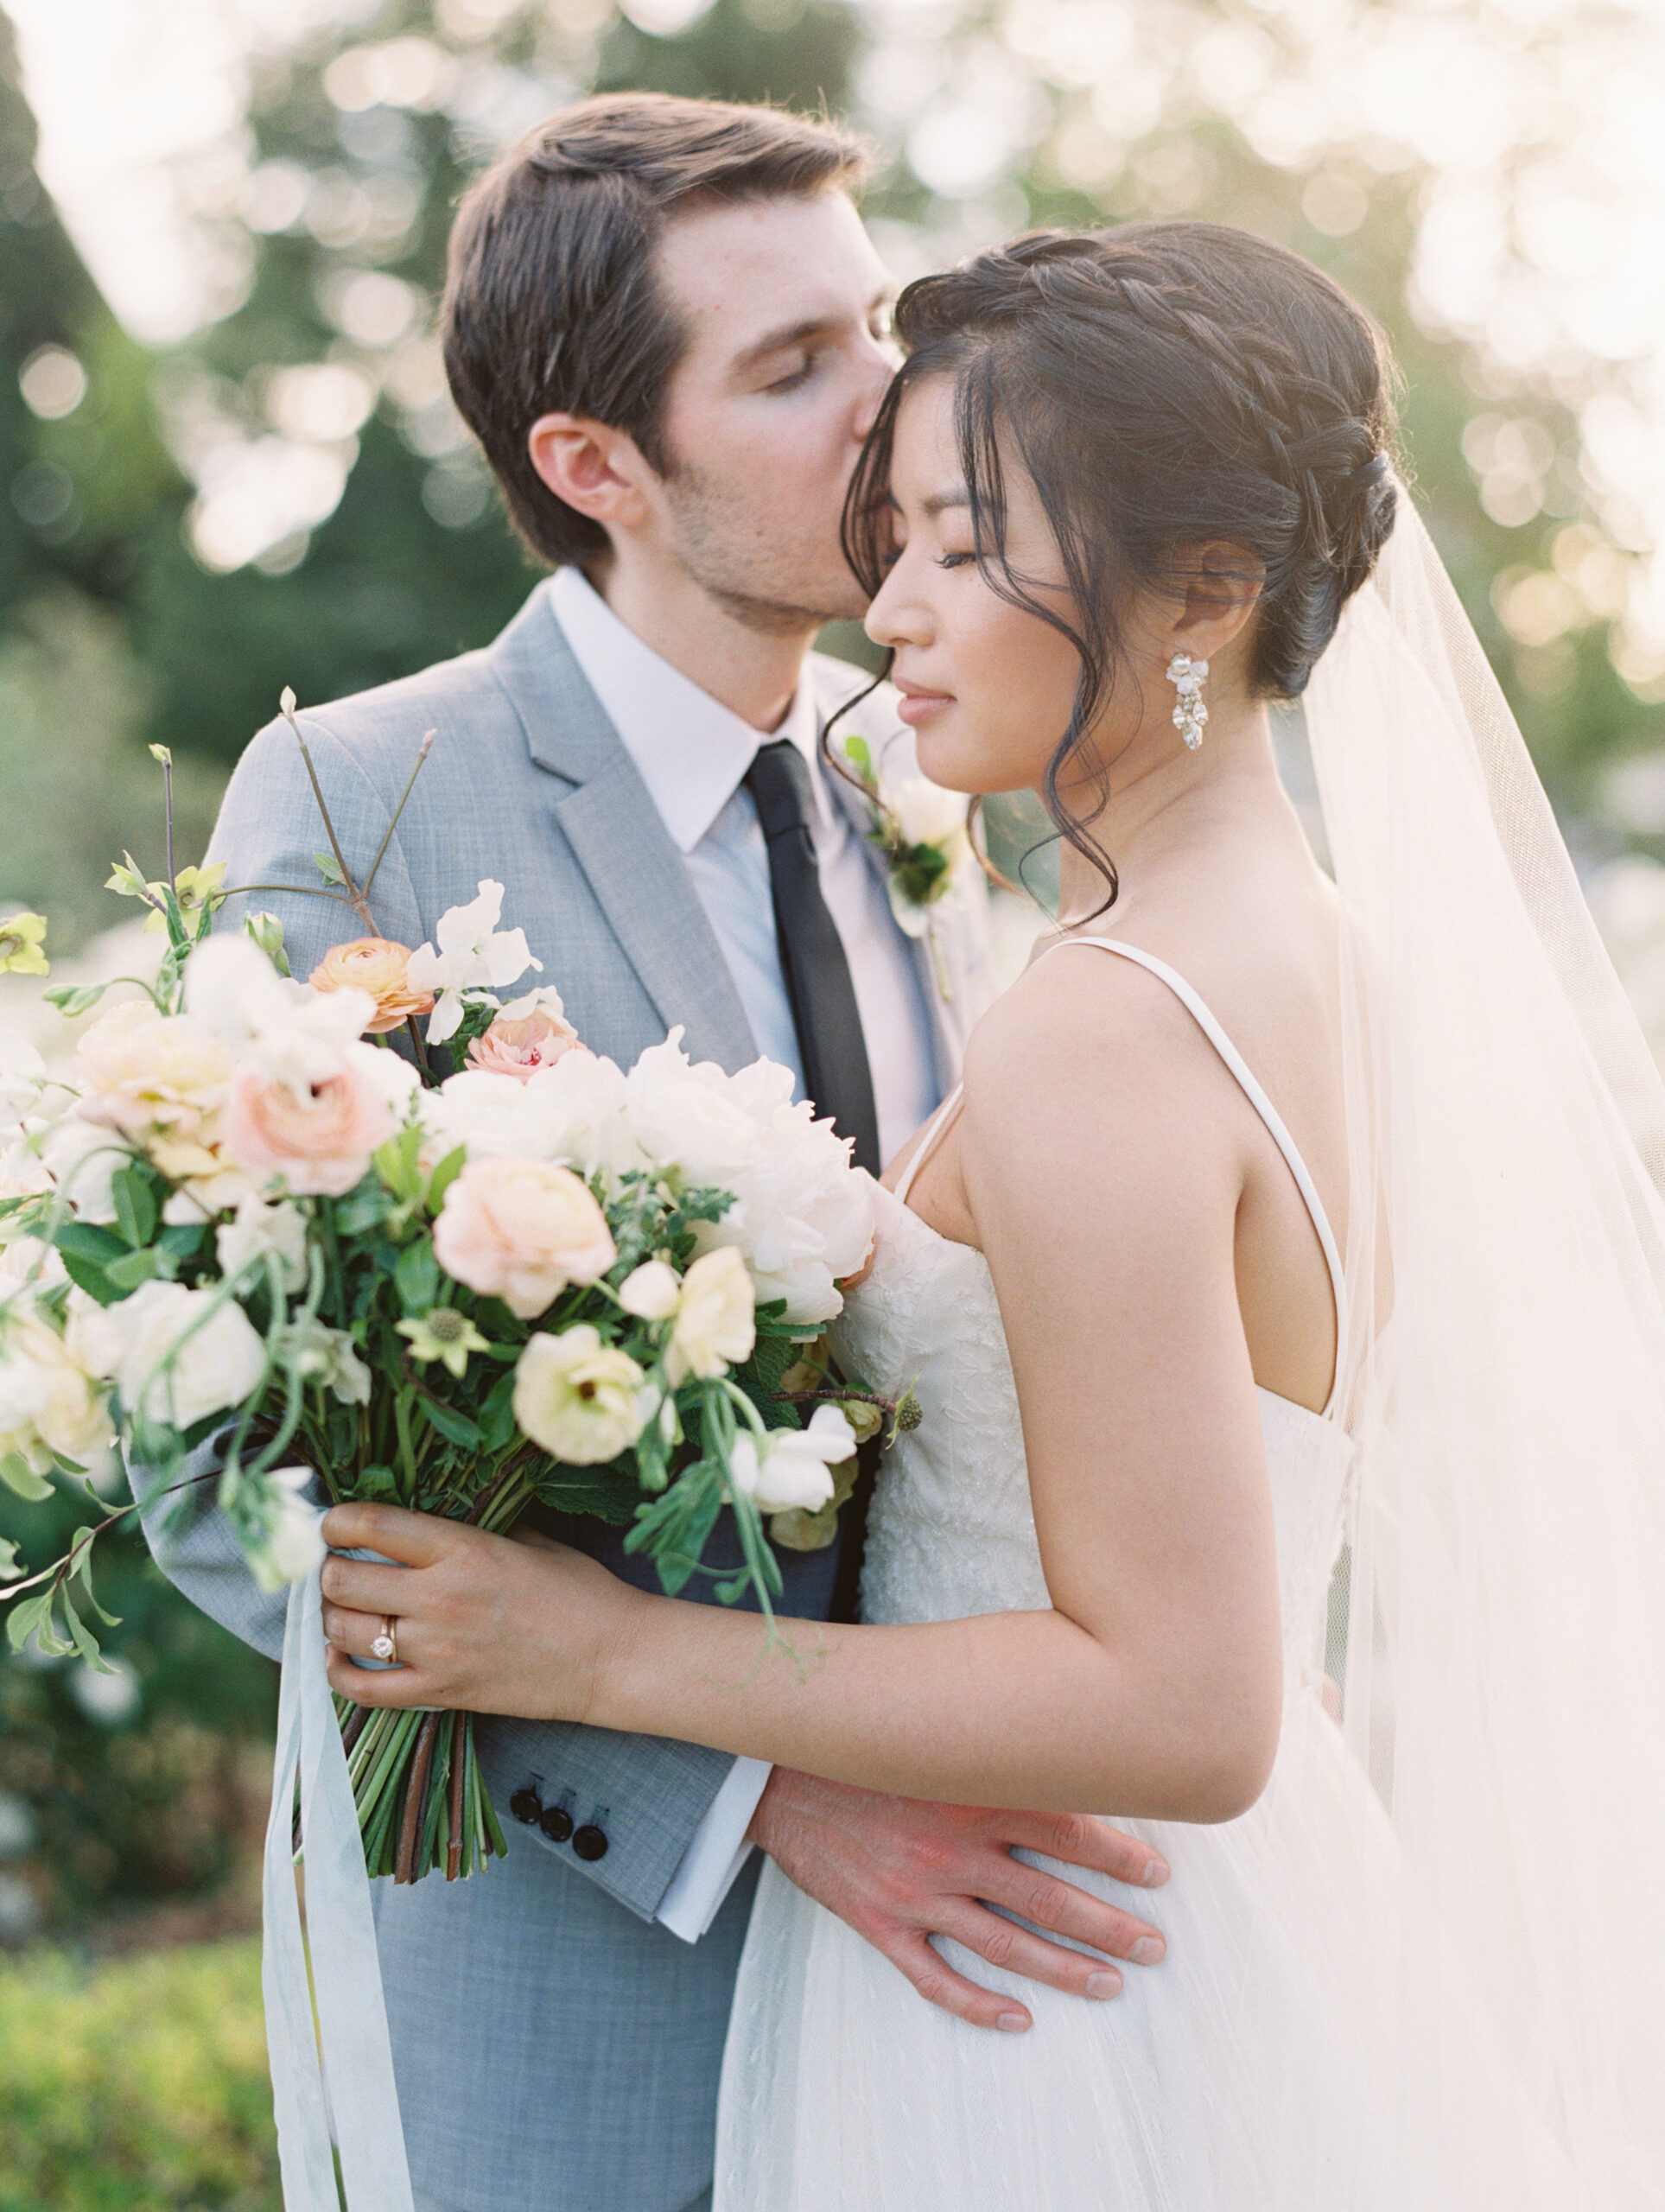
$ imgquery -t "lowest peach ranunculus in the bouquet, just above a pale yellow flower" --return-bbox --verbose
[434,1159,620,1320]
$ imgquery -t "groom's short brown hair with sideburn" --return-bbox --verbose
[442,93,867,566]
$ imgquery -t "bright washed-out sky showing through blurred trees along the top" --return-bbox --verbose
[11,0,1665,668]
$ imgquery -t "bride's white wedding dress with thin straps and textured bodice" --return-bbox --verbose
[715,938,1581,2212]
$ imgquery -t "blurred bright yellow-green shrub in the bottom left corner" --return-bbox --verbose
[0,1942,281,2212]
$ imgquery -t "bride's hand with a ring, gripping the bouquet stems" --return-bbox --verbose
[323,1504,644,1721]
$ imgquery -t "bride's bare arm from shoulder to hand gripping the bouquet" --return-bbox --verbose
[325,963,1282,1821]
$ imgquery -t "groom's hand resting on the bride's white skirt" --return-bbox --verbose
[747,1767,1167,2035]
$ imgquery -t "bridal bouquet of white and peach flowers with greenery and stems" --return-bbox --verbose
[0,760,878,1880]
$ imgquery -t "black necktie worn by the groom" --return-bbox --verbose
[745,736,880,1174]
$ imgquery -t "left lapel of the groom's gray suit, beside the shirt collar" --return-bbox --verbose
[480,591,756,1068]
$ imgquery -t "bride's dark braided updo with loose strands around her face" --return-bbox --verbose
[845,221,1395,900]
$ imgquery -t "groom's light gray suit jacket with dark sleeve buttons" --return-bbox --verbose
[148,586,988,2212]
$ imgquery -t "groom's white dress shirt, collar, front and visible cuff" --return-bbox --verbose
[550,566,937,1942]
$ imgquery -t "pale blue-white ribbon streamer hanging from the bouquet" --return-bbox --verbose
[261,1568,414,2212]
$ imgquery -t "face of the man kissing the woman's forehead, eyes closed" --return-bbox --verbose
[641,193,895,632]
